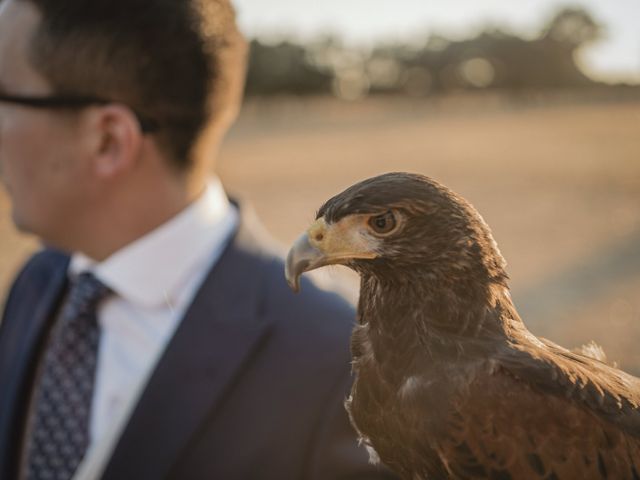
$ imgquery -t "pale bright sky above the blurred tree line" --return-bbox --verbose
[233,0,640,83]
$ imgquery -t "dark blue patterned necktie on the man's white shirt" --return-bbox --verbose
[26,273,111,480]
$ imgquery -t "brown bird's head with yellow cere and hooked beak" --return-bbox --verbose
[286,173,507,291]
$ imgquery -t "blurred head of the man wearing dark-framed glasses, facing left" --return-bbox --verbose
[0,0,246,255]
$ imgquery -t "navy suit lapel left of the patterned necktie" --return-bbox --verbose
[0,252,68,478]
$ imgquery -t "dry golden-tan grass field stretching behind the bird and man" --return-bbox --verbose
[0,93,640,374]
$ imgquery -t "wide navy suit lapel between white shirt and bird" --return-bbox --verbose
[102,218,276,480]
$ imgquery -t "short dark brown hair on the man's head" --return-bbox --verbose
[23,0,246,168]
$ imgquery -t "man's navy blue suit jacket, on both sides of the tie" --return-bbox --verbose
[0,212,391,480]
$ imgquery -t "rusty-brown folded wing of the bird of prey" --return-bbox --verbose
[436,368,640,479]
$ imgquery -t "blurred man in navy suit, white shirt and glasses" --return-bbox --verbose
[0,0,396,480]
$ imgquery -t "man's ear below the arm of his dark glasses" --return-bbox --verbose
[91,104,143,179]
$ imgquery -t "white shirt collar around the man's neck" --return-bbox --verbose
[69,178,238,307]
